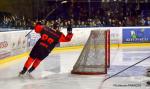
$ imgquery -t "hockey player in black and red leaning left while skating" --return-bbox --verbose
[19,22,73,76]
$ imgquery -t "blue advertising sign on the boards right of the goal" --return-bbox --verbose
[122,28,150,43]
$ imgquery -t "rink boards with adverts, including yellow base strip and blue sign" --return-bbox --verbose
[0,27,150,64]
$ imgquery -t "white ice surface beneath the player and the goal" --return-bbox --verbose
[0,48,150,89]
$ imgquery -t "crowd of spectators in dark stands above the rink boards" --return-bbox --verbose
[0,3,150,29]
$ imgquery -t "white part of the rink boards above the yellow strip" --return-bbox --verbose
[0,27,150,59]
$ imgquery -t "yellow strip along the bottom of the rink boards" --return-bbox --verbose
[0,43,150,65]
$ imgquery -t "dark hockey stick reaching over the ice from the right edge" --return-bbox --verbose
[100,56,150,89]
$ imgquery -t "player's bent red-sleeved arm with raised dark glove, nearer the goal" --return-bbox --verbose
[59,23,73,42]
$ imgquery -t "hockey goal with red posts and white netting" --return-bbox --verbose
[71,30,110,75]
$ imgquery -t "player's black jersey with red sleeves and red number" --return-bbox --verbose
[35,25,73,52]
